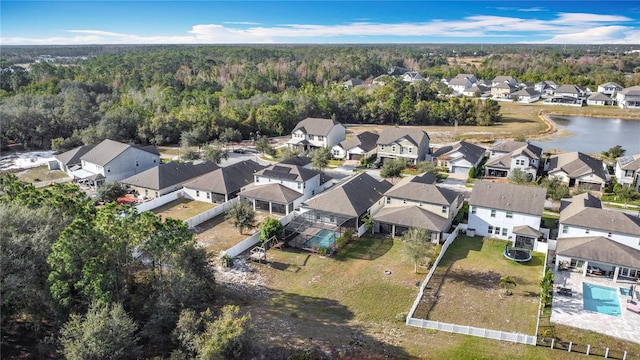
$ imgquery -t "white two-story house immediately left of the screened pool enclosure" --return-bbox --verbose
[238,163,331,215]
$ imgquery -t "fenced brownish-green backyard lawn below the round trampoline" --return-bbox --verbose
[415,236,544,335]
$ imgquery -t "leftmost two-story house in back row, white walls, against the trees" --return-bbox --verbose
[287,118,346,151]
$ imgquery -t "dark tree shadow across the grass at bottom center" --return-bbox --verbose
[221,284,412,359]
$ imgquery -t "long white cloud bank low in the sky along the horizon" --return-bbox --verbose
[0,8,640,45]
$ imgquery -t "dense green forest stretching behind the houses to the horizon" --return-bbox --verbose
[0,45,640,149]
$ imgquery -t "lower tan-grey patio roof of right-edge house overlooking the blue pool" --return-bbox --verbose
[556,236,640,269]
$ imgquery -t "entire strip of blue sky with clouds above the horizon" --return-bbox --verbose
[0,0,640,47]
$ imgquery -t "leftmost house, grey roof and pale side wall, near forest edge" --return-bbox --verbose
[70,139,160,186]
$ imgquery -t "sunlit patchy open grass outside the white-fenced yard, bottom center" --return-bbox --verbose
[223,238,596,359]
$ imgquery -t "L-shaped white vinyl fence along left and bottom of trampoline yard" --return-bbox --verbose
[406,224,537,346]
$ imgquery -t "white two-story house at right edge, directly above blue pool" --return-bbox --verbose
[549,193,640,282]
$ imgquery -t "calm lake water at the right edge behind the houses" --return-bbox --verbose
[532,116,640,155]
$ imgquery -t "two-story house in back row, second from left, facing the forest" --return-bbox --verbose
[377,127,429,164]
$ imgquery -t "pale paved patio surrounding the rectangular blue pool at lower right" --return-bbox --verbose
[551,271,640,344]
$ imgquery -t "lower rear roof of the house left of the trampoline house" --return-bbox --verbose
[373,206,449,232]
